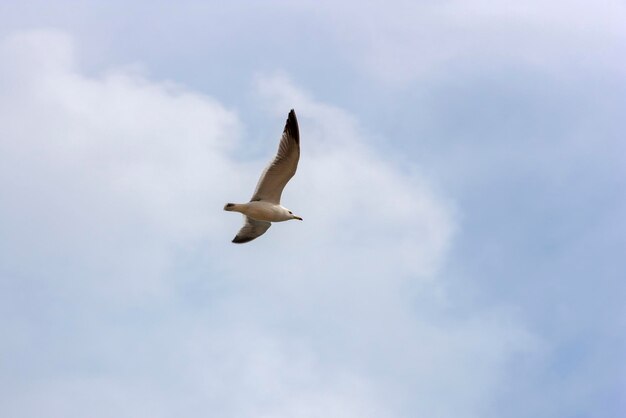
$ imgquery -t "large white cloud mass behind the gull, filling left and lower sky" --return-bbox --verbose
[0,31,536,417]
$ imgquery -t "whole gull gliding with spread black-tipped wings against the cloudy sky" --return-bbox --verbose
[224,109,302,244]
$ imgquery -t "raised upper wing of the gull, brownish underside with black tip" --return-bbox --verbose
[250,109,300,205]
